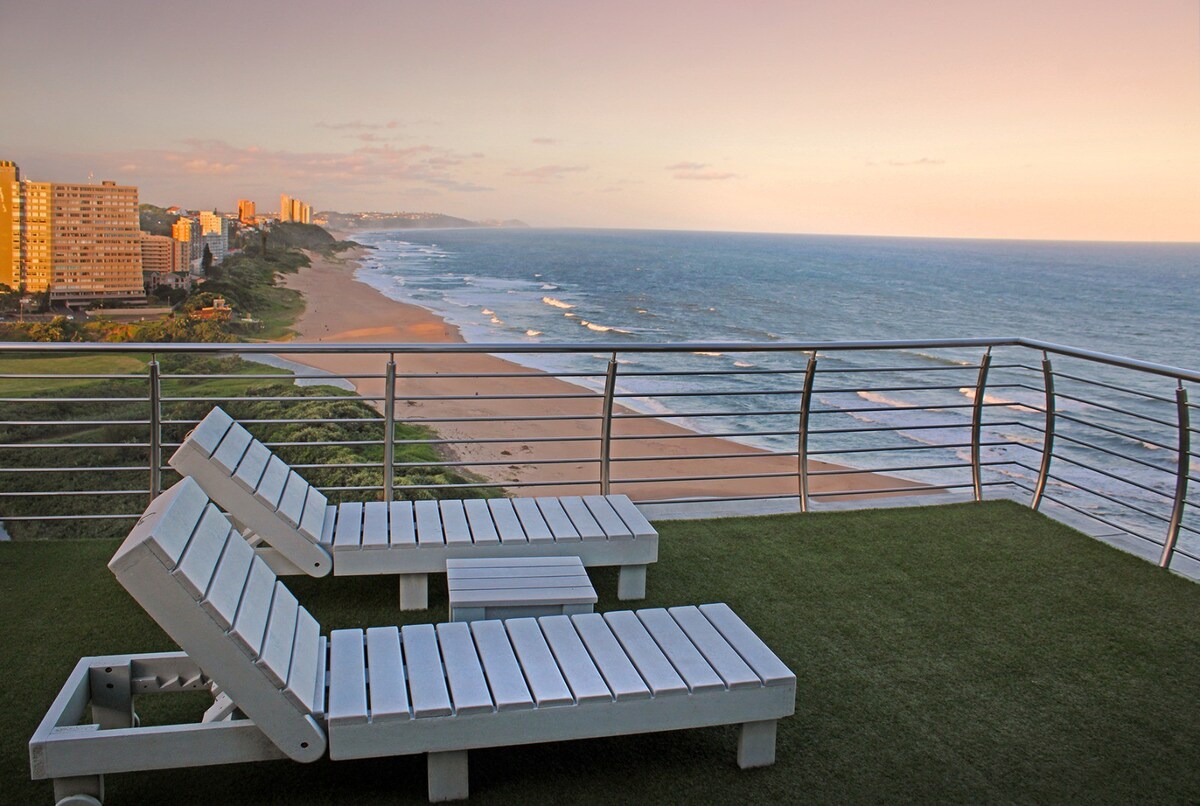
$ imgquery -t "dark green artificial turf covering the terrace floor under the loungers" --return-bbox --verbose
[0,501,1200,804]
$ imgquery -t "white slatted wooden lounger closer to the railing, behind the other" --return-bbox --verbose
[170,408,659,609]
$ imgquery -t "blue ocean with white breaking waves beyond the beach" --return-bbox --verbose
[354,229,1200,549]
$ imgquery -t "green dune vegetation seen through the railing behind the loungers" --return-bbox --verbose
[0,355,502,540]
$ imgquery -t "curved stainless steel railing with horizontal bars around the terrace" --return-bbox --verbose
[0,338,1200,566]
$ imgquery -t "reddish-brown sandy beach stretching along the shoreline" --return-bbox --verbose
[283,243,912,500]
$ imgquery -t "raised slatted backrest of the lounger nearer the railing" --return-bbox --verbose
[170,407,334,577]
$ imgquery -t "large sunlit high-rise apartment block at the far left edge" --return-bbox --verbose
[0,162,145,302]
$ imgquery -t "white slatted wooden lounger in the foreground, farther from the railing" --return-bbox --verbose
[29,479,796,806]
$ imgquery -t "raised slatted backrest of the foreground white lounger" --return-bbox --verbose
[108,477,325,760]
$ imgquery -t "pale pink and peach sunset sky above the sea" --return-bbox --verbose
[0,0,1200,241]
